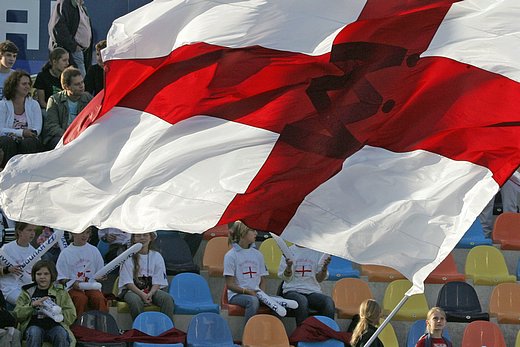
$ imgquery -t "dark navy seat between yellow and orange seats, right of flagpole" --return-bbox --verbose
[437,281,489,323]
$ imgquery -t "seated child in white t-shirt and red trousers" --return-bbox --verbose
[56,228,108,317]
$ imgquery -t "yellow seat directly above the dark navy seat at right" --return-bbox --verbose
[465,246,516,285]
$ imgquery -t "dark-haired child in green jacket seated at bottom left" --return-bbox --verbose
[14,260,76,347]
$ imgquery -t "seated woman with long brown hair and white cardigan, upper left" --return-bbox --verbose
[0,70,43,167]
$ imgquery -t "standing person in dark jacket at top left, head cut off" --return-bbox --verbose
[49,0,93,77]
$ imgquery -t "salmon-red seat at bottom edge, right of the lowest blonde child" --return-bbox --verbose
[462,320,506,347]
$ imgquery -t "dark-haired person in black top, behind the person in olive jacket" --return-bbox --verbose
[34,47,69,112]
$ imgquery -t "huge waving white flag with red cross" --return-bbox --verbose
[0,0,520,292]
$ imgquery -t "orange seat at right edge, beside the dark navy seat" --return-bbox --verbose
[489,283,520,324]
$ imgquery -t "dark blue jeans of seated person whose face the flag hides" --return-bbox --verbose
[283,291,336,325]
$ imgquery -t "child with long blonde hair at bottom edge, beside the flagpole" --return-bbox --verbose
[350,299,384,347]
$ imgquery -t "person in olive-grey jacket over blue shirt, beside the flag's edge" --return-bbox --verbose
[43,66,92,149]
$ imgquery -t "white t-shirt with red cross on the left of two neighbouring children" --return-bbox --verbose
[224,243,269,300]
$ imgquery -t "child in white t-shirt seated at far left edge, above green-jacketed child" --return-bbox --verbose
[0,222,36,306]
